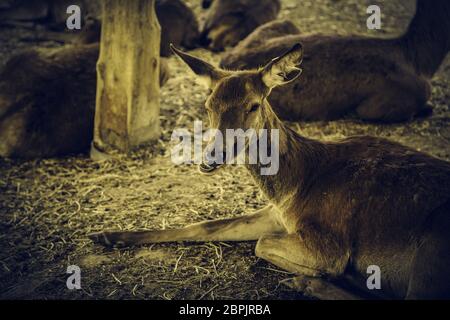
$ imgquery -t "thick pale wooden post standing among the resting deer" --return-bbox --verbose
[93,0,161,153]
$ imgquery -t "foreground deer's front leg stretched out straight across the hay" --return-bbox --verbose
[89,205,285,246]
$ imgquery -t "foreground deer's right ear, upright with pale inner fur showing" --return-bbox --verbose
[261,43,303,89]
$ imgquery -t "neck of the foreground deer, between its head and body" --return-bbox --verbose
[247,102,326,207]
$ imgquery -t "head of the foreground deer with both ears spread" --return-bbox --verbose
[171,44,303,173]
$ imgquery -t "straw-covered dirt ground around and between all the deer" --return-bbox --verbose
[0,0,450,299]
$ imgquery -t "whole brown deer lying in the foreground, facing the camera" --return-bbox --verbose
[90,44,450,299]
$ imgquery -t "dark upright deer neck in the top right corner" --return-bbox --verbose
[400,0,450,77]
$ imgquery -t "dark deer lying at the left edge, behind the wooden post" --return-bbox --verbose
[0,43,168,158]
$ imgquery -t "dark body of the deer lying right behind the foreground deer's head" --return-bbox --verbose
[270,36,431,122]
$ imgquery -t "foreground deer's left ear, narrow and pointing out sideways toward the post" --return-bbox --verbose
[170,44,227,88]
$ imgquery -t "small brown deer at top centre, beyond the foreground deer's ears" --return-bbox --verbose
[200,0,281,51]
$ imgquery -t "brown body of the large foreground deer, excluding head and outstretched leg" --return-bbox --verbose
[249,123,450,298]
